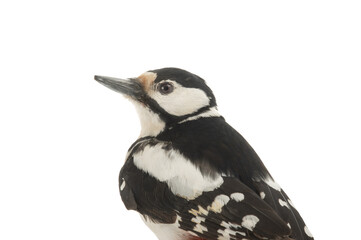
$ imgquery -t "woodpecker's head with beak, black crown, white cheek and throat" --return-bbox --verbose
[94,68,218,136]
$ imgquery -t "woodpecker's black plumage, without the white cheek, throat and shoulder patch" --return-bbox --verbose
[95,68,313,240]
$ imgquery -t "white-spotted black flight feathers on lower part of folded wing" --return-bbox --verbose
[176,177,291,240]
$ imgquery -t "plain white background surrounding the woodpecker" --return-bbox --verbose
[0,0,361,240]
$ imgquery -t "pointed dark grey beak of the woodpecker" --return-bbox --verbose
[94,75,144,100]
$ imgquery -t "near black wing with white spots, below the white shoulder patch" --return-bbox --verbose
[119,158,291,240]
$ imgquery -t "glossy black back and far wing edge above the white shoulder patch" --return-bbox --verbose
[157,118,313,240]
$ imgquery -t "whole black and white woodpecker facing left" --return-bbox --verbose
[95,68,313,240]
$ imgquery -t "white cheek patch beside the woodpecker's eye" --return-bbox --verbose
[149,80,210,116]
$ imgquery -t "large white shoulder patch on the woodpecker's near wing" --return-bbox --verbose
[133,143,223,199]
